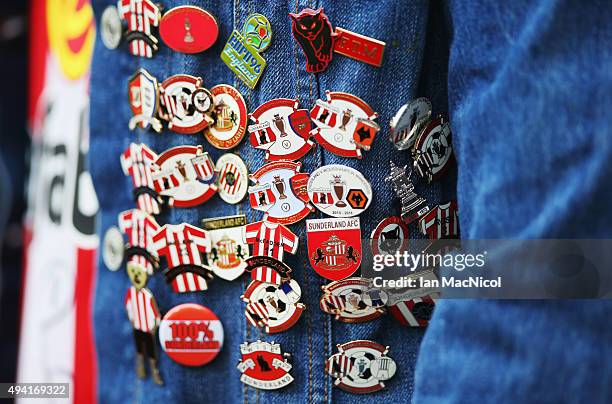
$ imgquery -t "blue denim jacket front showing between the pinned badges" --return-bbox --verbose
[90,0,448,403]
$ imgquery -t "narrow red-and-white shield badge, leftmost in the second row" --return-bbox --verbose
[128,69,162,132]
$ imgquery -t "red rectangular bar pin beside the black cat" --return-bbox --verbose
[334,27,386,67]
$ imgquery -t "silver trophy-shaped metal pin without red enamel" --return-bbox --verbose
[385,161,429,224]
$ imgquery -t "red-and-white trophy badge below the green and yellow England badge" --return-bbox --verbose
[248,98,314,161]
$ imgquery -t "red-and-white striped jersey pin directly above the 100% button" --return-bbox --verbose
[153,223,212,293]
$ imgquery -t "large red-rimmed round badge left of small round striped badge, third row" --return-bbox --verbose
[152,146,217,208]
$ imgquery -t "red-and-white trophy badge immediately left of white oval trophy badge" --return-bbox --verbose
[249,161,314,224]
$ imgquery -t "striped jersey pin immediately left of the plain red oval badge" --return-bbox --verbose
[117,0,161,58]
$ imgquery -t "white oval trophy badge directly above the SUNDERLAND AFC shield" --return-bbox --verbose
[307,164,372,217]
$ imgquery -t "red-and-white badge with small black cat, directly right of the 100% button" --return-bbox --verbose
[238,341,293,390]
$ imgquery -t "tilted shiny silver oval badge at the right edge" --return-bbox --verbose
[389,97,431,150]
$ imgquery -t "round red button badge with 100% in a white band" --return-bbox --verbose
[159,303,223,366]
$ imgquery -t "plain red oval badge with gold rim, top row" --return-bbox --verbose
[159,6,219,53]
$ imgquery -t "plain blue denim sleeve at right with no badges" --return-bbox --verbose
[414,1,612,403]
